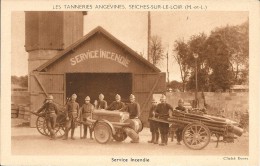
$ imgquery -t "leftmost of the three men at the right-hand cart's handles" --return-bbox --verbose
[148,99,159,144]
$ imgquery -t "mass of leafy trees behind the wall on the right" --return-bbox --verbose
[173,21,249,91]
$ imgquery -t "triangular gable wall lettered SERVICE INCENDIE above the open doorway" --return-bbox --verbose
[45,34,154,73]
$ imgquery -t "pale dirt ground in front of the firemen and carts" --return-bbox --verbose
[11,122,249,156]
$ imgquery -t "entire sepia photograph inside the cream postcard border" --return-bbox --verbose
[12,11,249,156]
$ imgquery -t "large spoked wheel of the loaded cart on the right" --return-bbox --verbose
[182,123,210,150]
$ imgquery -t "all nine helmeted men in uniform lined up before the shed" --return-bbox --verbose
[37,94,186,146]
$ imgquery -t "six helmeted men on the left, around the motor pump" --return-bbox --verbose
[37,94,140,140]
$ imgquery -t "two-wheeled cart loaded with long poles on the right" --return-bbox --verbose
[150,110,243,150]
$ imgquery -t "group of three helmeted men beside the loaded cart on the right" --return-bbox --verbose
[148,95,187,146]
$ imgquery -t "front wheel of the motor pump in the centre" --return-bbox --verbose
[94,122,112,144]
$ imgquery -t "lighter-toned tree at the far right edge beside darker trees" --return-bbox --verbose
[212,20,249,84]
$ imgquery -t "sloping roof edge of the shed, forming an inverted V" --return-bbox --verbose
[36,26,160,72]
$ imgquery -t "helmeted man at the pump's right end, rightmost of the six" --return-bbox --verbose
[119,94,140,143]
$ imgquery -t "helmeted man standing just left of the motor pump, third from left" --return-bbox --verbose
[78,96,94,139]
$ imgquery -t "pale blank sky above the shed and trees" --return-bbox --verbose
[11,11,248,81]
